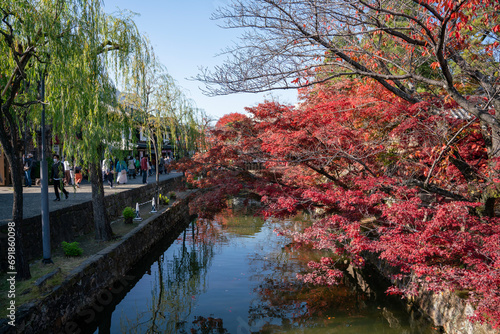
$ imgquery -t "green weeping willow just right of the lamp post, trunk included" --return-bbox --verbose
[48,1,141,240]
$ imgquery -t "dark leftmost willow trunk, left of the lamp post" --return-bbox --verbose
[4,146,31,280]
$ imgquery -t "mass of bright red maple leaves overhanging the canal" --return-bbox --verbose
[177,80,500,327]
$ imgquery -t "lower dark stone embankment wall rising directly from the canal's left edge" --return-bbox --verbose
[0,192,193,334]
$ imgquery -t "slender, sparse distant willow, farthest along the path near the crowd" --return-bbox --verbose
[122,38,209,206]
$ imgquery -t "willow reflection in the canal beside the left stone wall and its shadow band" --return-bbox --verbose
[122,223,218,333]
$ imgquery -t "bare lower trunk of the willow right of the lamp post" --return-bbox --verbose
[89,162,113,241]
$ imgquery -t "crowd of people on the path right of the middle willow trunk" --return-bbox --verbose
[102,154,171,188]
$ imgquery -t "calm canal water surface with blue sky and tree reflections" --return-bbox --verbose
[85,212,438,334]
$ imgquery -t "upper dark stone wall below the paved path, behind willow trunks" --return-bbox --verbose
[0,177,182,271]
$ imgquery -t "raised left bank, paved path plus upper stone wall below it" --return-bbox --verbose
[0,173,183,272]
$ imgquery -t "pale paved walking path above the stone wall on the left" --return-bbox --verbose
[0,172,182,222]
